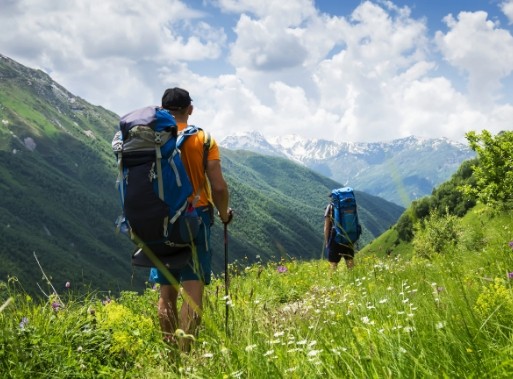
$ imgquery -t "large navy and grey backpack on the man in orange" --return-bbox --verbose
[112,106,210,269]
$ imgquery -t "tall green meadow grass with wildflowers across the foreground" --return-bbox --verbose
[0,211,513,378]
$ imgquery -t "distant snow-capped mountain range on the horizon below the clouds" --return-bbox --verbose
[220,131,475,207]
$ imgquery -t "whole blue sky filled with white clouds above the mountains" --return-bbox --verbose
[0,0,513,142]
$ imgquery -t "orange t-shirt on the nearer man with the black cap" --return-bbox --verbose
[178,122,221,207]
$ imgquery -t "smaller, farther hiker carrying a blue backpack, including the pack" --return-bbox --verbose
[324,187,362,271]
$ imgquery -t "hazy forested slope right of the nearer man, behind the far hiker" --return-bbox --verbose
[208,149,403,270]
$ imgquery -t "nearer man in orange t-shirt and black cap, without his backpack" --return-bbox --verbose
[150,88,232,351]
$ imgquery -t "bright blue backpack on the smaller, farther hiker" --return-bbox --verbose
[330,187,362,246]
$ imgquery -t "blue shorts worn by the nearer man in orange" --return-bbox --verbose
[149,207,212,285]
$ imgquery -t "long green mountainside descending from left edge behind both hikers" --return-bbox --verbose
[0,55,404,296]
